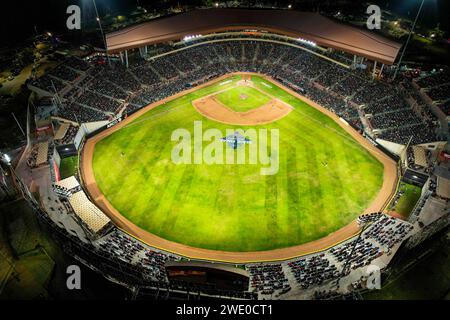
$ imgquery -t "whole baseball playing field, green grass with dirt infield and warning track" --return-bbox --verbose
[81,74,396,261]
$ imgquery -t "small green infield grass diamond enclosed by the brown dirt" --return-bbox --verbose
[216,86,271,112]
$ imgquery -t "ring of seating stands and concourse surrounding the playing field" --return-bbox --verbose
[16,24,450,299]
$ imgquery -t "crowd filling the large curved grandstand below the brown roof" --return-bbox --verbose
[30,37,440,144]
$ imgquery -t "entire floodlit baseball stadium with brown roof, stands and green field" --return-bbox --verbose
[0,4,450,300]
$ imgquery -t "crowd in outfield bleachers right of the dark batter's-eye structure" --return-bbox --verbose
[247,212,413,294]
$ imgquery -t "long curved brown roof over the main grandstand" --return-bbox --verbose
[106,9,401,65]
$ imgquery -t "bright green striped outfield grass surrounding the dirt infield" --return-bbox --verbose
[93,76,383,251]
